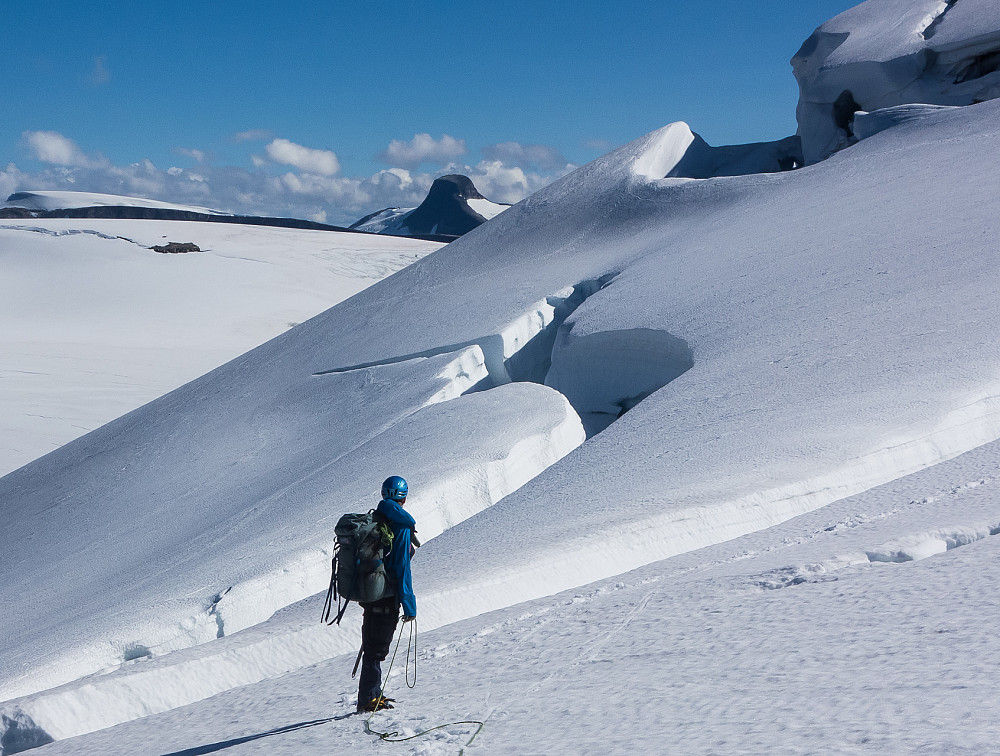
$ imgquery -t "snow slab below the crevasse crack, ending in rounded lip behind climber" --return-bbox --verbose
[0,340,584,696]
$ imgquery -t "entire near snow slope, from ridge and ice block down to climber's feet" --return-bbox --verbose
[0,0,1000,756]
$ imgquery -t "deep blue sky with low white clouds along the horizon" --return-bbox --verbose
[0,0,855,222]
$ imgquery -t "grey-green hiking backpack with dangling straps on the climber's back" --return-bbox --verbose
[322,509,396,625]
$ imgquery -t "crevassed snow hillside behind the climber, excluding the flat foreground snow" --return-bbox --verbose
[0,96,1000,752]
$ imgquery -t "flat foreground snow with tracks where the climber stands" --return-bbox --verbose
[25,434,1000,756]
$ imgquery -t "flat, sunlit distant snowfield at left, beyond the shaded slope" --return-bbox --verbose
[0,217,439,474]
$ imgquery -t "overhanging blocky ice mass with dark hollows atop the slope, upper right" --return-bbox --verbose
[792,0,1000,163]
